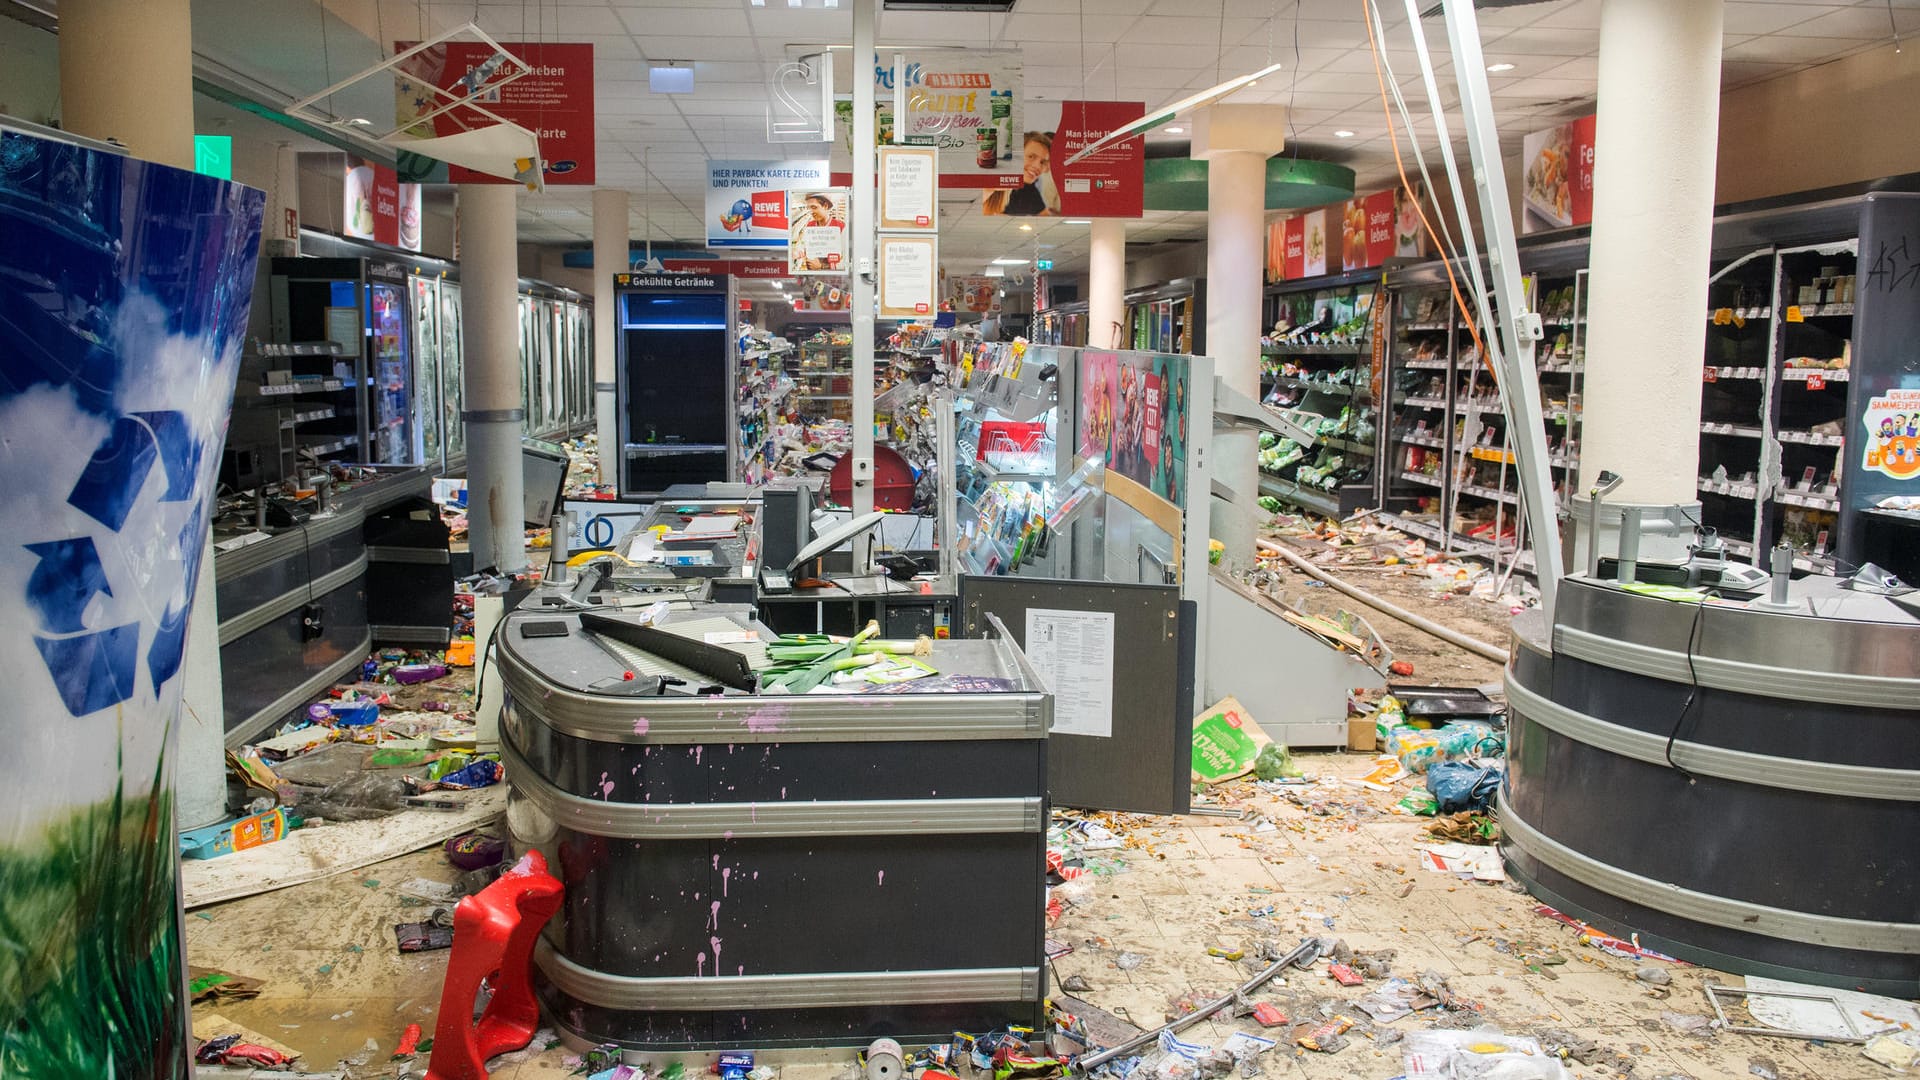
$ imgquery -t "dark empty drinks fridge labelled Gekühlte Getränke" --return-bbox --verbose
[620,292,732,492]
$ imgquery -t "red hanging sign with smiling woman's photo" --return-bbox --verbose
[981,102,1146,217]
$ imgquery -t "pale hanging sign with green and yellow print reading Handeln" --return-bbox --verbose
[833,48,1027,188]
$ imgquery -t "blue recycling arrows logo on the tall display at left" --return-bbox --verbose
[25,411,205,717]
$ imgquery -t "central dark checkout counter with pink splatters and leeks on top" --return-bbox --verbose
[493,588,1052,1051]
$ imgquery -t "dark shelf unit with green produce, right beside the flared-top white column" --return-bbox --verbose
[1260,275,1380,517]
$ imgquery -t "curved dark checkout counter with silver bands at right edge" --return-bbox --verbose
[1500,575,1920,997]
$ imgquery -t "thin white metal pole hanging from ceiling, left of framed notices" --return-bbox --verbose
[847,0,877,575]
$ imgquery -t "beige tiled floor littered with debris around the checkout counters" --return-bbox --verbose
[186,755,1885,1080]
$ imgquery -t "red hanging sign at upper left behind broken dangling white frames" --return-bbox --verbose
[394,40,593,186]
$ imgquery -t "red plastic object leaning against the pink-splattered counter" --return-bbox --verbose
[426,851,561,1080]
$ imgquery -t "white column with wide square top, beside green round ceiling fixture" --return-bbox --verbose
[1192,106,1286,565]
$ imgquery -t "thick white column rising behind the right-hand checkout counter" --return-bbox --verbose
[1574,0,1722,553]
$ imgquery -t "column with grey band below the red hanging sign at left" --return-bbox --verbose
[459,184,526,571]
